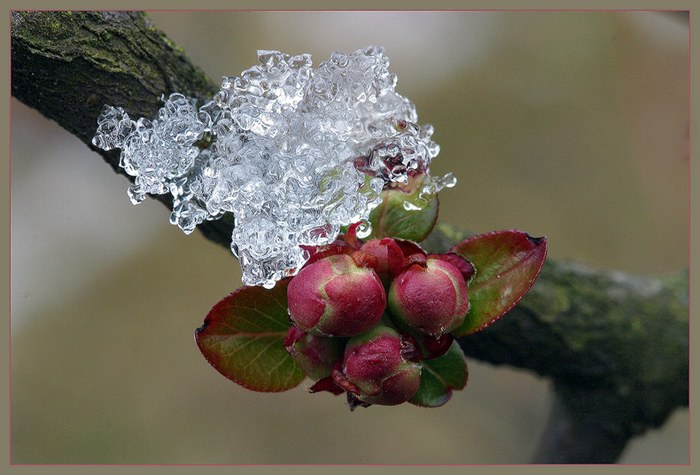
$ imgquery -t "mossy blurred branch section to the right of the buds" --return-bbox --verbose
[423,224,688,463]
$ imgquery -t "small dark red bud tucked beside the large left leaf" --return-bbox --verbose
[284,327,346,381]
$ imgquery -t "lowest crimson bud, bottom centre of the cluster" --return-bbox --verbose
[333,325,420,406]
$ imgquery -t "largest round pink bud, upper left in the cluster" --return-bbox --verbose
[287,254,386,337]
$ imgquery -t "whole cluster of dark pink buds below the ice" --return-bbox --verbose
[285,226,474,409]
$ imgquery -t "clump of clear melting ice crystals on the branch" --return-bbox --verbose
[93,47,454,288]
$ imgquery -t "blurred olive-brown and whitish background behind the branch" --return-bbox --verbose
[12,12,689,464]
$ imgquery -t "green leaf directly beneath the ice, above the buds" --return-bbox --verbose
[369,177,439,242]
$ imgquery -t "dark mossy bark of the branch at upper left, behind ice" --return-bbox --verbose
[11,11,233,246]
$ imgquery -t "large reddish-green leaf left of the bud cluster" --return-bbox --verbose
[195,280,304,392]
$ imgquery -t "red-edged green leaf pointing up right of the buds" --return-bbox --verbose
[451,230,547,336]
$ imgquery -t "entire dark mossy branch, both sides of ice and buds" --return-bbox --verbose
[12,12,688,463]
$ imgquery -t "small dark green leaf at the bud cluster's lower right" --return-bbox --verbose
[409,342,469,407]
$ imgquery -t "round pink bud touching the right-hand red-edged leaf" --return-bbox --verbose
[388,257,469,336]
